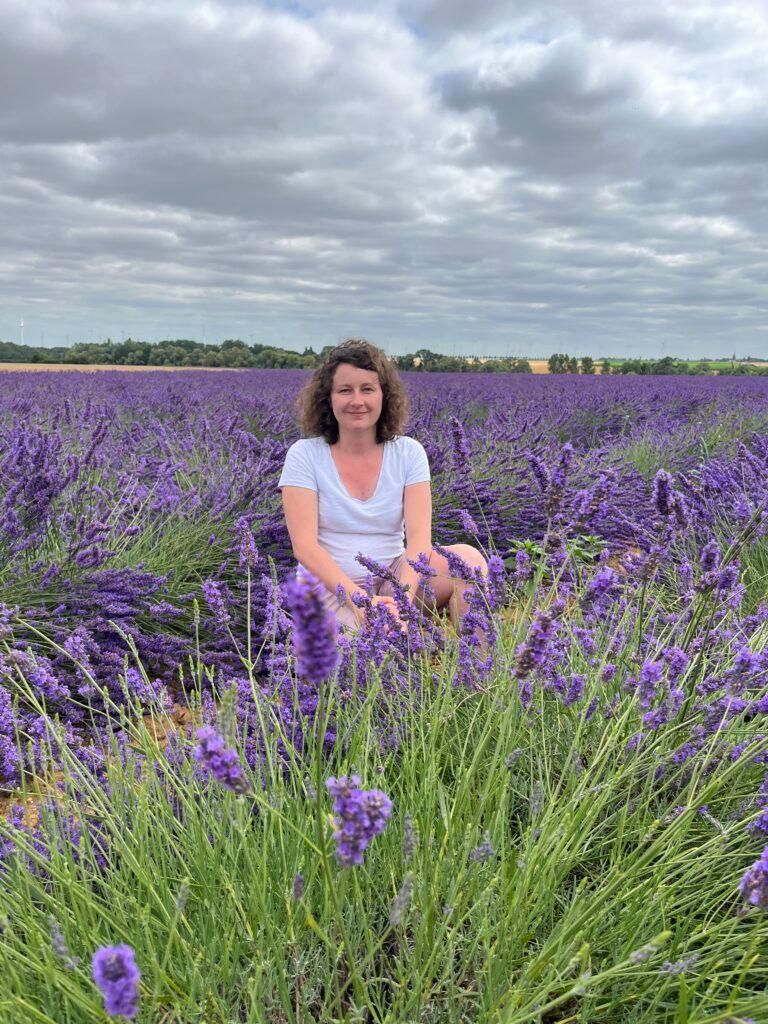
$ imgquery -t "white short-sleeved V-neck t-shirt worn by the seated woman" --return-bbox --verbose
[278,437,429,582]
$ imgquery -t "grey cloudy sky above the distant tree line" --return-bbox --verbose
[0,0,768,356]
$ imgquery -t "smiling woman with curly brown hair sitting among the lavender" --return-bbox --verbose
[278,338,487,628]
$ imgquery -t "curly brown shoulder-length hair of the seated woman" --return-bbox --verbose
[296,338,408,444]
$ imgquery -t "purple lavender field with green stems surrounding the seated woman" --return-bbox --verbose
[0,371,768,1024]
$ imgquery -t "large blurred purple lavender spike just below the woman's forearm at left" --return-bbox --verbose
[285,577,339,683]
